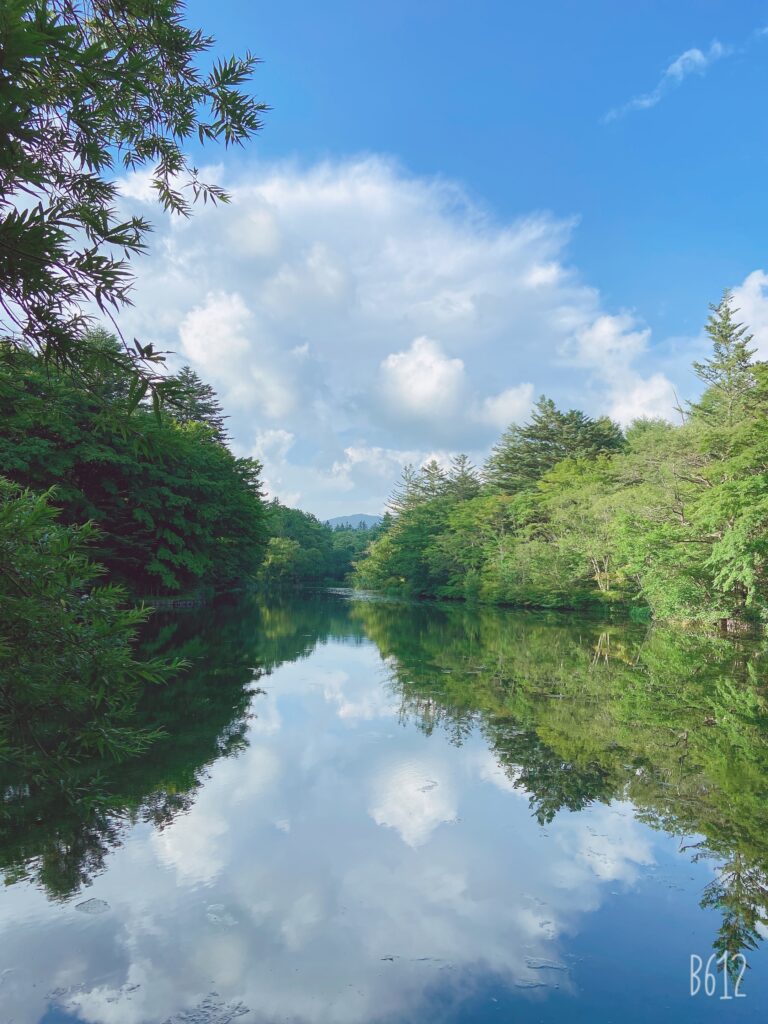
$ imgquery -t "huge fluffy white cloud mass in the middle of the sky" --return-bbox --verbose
[118,157,684,518]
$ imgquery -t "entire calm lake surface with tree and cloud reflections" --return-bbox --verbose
[0,593,768,1024]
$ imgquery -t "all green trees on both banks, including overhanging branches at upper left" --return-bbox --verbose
[0,0,768,790]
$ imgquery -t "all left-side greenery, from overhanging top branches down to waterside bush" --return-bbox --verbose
[0,0,382,777]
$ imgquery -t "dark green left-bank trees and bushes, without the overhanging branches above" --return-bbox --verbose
[0,331,377,771]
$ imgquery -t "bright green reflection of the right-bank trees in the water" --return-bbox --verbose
[352,601,768,953]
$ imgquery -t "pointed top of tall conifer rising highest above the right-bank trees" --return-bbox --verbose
[691,289,757,427]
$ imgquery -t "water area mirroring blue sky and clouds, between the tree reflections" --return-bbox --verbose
[0,597,768,1024]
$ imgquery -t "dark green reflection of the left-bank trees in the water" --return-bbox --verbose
[0,595,362,900]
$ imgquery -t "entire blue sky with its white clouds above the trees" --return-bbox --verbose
[118,0,768,515]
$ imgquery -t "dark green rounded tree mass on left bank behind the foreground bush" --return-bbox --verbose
[0,335,266,593]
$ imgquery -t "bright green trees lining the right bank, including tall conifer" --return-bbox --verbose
[355,293,768,629]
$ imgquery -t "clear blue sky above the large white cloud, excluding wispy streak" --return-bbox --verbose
[190,0,768,333]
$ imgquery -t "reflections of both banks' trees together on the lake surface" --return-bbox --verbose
[0,594,768,963]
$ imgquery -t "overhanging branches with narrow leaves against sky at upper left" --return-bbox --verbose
[0,0,264,393]
